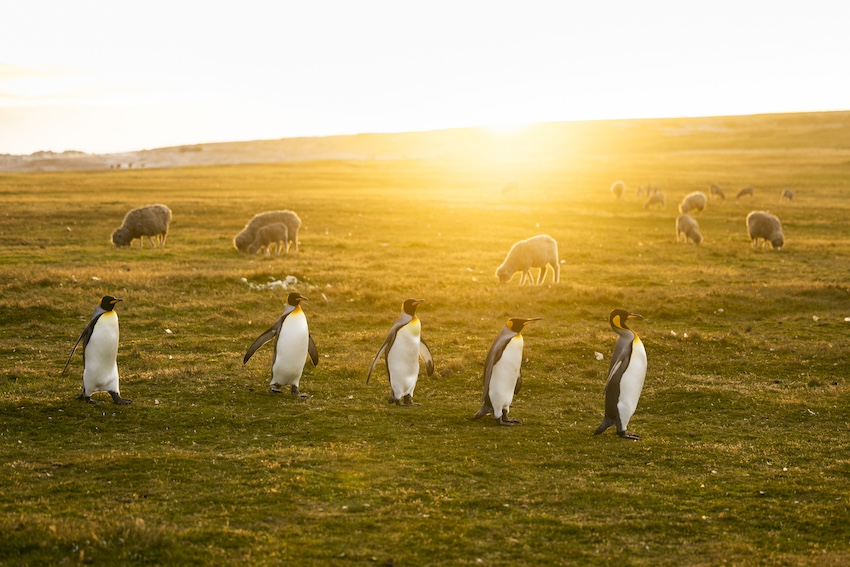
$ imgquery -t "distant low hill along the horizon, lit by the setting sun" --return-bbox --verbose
[0,111,850,172]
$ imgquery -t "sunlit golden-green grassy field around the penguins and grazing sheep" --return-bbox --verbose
[0,114,850,565]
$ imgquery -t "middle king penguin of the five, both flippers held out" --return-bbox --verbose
[366,299,434,406]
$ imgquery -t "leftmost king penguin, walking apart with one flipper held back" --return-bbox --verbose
[62,295,133,406]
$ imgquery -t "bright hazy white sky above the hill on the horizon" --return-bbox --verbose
[0,0,850,154]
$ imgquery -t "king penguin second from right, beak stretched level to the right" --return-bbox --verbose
[473,317,541,425]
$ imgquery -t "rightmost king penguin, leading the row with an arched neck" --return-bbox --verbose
[594,309,646,440]
